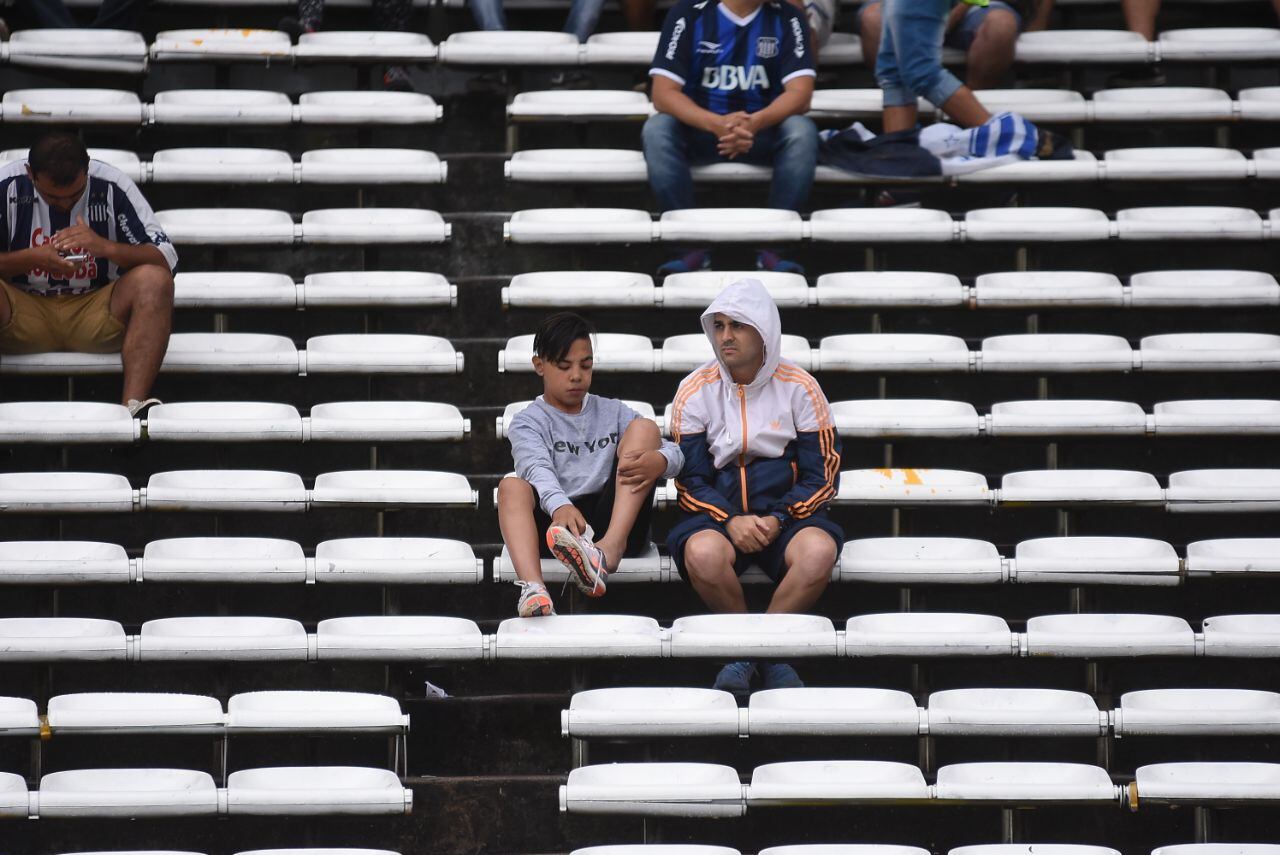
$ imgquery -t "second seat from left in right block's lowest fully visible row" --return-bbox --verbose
[746,760,929,808]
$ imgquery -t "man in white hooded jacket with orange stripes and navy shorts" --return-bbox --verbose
[667,279,844,698]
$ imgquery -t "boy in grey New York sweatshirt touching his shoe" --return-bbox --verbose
[498,312,684,617]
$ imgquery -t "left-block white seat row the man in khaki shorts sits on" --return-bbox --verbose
[0,333,463,376]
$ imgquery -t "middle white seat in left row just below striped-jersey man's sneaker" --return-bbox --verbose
[147,401,302,443]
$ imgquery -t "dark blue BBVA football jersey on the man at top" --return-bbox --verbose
[649,0,817,115]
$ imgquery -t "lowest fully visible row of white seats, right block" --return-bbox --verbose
[559,760,1280,817]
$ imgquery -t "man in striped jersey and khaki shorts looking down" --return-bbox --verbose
[0,133,178,415]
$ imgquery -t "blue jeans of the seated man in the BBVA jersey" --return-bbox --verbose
[644,113,818,211]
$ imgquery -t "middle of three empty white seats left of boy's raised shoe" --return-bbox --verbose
[138,538,307,584]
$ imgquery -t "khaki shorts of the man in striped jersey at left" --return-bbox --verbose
[0,282,124,353]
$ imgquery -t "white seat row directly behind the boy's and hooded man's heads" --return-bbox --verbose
[496,333,1280,374]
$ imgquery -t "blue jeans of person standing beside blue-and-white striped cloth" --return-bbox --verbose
[876,0,960,106]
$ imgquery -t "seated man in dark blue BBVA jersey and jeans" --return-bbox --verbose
[644,0,818,274]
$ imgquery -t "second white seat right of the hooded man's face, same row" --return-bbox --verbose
[978,333,1134,372]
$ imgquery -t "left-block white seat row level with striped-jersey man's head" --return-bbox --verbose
[0,148,449,184]
